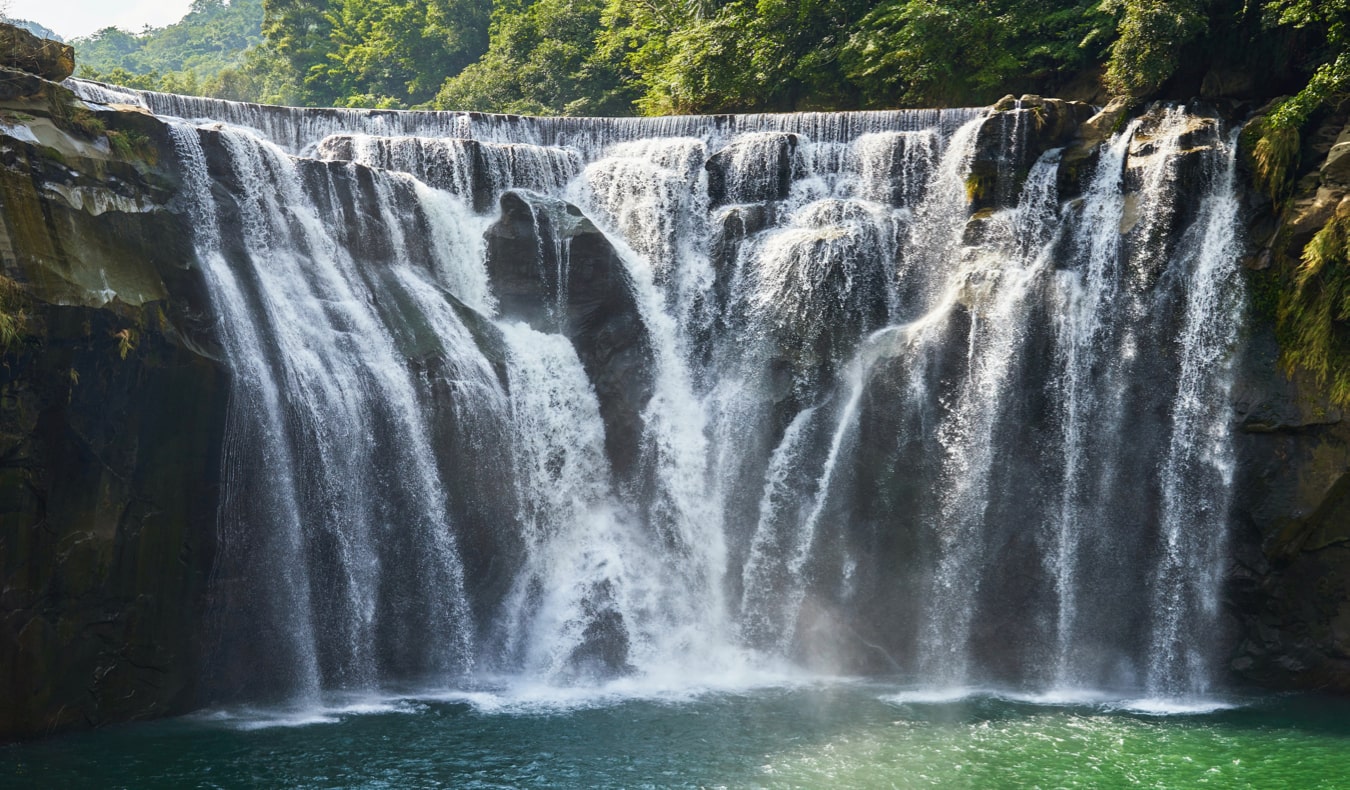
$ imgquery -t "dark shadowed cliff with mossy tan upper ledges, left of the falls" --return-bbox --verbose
[0,36,227,740]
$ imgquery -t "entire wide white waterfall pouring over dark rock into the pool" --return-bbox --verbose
[142,80,1243,705]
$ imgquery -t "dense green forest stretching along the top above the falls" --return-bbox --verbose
[68,0,1350,116]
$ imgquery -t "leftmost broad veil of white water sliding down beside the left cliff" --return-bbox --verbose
[174,120,486,695]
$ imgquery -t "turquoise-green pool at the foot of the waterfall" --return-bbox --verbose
[0,682,1350,789]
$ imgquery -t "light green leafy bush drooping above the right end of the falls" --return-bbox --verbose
[1102,0,1208,99]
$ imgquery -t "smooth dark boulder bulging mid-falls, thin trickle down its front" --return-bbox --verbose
[487,192,652,482]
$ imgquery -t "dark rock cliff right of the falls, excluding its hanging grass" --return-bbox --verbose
[1229,113,1350,693]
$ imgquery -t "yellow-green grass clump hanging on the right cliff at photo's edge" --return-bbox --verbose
[1278,216,1350,406]
